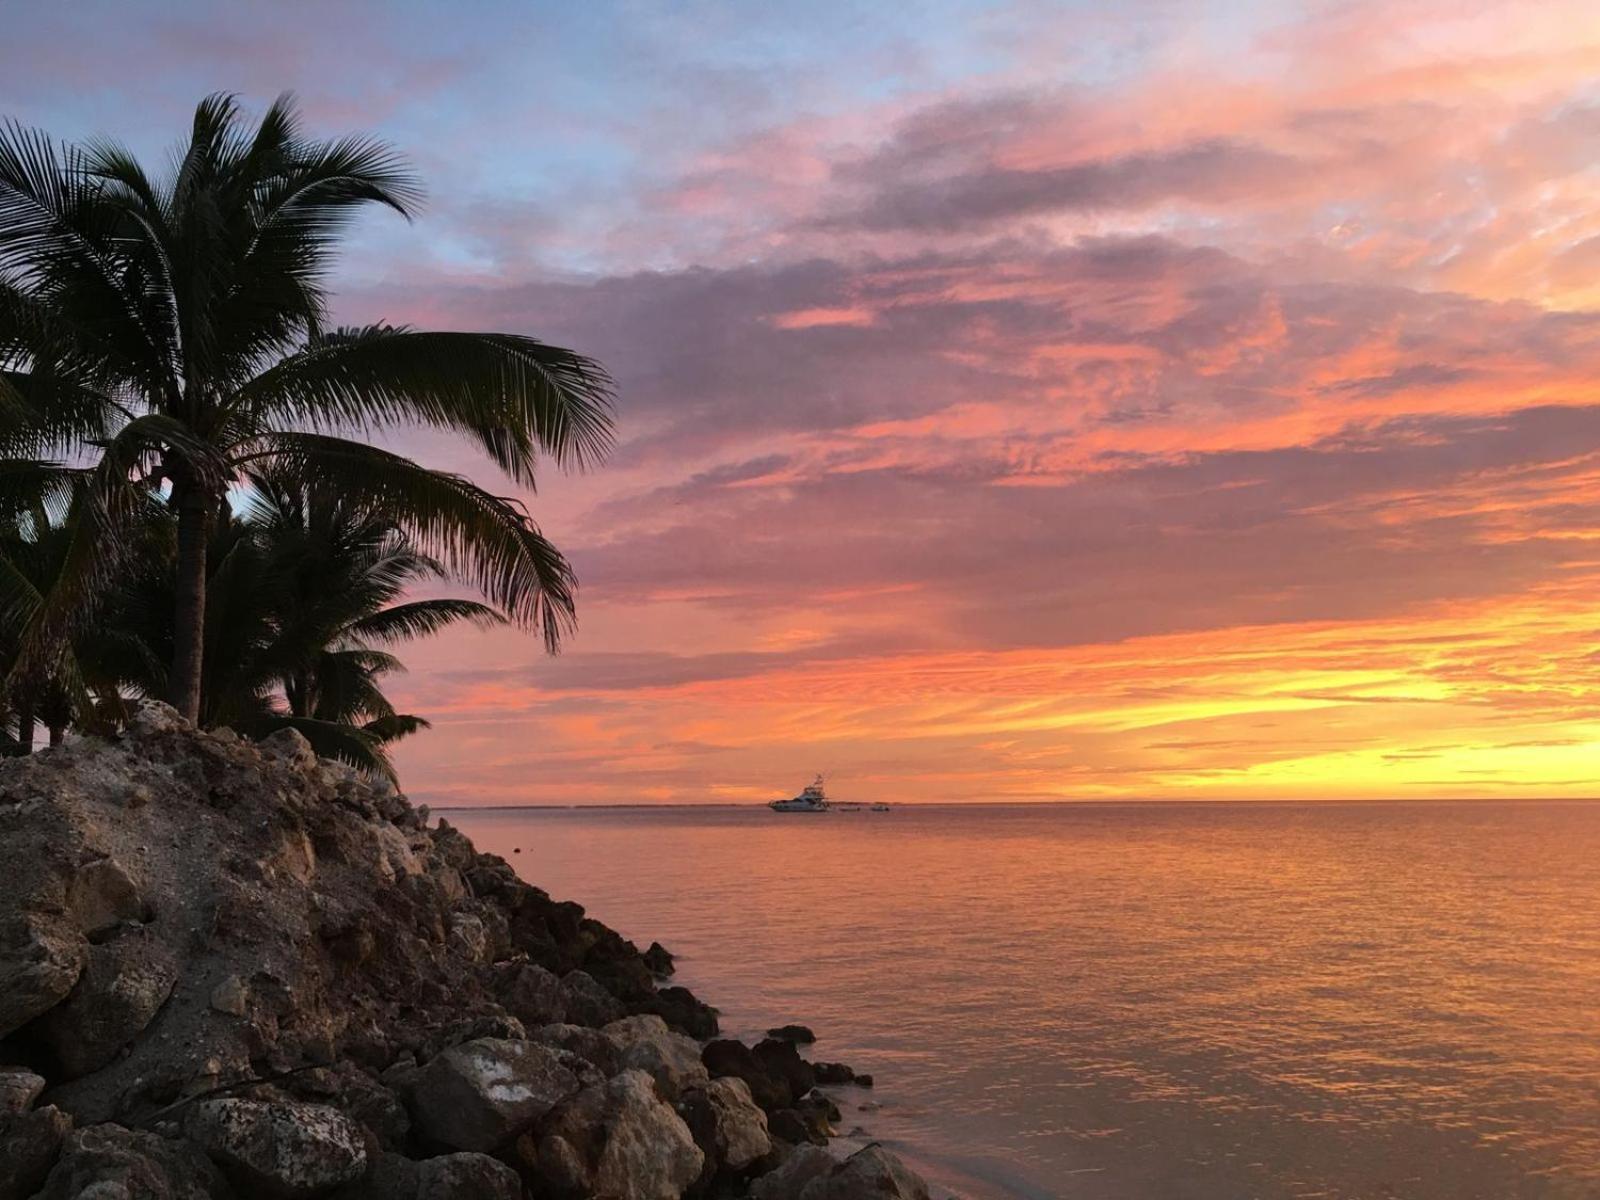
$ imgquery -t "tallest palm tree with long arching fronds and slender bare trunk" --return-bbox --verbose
[0,96,611,720]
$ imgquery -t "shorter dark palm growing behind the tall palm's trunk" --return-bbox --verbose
[95,474,506,774]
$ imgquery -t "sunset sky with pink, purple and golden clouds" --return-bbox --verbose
[0,0,1600,805]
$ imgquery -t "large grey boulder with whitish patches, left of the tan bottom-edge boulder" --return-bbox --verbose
[411,1038,579,1150]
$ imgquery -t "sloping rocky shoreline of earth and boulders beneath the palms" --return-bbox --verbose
[0,704,928,1200]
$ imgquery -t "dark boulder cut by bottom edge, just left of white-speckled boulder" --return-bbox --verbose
[37,1125,230,1200]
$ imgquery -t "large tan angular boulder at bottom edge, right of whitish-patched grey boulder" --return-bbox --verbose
[517,1070,706,1200]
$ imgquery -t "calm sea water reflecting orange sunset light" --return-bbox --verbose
[450,803,1600,1200]
